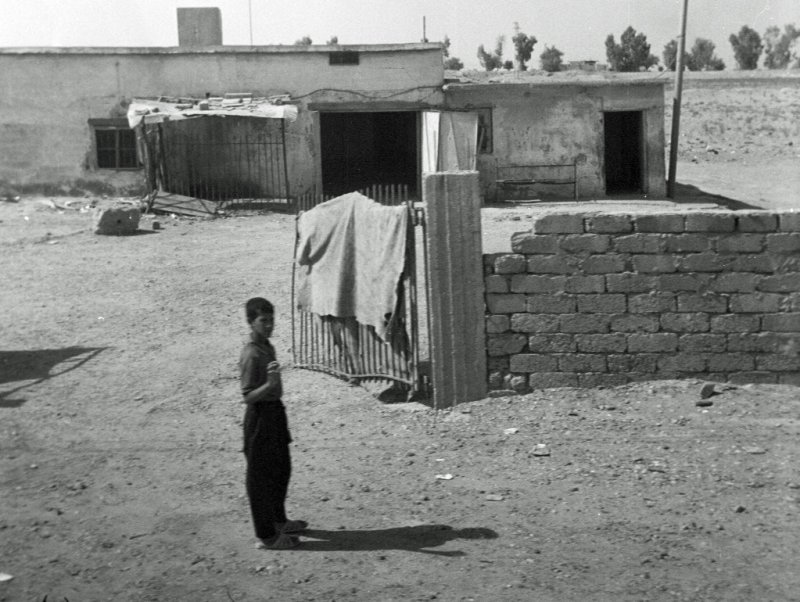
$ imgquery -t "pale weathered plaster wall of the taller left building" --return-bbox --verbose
[0,44,443,196]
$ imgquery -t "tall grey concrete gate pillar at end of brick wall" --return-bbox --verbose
[422,171,487,408]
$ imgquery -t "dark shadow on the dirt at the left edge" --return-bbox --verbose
[0,347,106,408]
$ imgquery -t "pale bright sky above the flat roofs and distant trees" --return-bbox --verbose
[0,0,800,69]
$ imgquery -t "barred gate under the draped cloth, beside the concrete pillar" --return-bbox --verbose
[292,186,429,399]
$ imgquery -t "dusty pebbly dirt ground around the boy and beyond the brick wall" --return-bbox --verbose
[0,72,800,602]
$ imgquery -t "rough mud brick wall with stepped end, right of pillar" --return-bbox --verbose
[484,211,800,392]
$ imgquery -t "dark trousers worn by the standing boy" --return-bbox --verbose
[244,401,292,539]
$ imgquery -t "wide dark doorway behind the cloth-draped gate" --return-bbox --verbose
[320,111,418,197]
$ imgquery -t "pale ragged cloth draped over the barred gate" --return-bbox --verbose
[295,192,408,340]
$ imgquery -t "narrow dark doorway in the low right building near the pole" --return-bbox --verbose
[603,111,642,194]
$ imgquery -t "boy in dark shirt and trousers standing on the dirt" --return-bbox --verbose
[239,297,308,550]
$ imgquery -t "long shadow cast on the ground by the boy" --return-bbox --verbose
[300,525,497,556]
